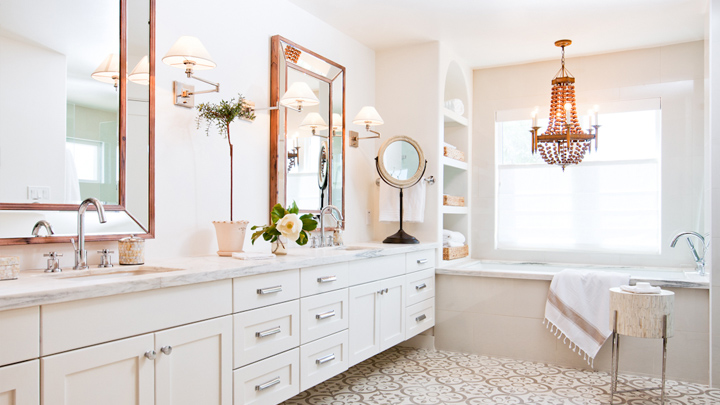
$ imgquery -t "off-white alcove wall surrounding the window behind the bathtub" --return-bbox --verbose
[472,41,705,267]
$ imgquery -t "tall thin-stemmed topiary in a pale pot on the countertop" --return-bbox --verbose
[197,94,255,256]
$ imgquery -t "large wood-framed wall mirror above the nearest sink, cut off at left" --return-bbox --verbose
[0,0,155,245]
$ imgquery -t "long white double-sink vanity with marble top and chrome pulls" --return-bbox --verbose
[0,244,436,405]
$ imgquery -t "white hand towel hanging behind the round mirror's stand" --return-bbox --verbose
[380,180,425,222]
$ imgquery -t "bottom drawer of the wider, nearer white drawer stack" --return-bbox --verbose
[233,348,300,405]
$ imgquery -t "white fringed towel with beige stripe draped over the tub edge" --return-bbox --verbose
[543,269,630,366]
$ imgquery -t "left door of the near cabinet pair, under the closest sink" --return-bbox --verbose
[41,334,155,405]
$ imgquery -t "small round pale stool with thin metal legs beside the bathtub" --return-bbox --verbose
[610,287,675,404]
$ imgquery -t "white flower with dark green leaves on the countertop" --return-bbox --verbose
[250,201,317,255]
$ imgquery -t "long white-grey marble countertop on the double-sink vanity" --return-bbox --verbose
[0,243,440,311]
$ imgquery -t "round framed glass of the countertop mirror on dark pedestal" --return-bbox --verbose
[378,135,425,188]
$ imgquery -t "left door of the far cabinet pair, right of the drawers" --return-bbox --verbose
[348,281,380,366]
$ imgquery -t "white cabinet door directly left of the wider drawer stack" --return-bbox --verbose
[155,316,232,405]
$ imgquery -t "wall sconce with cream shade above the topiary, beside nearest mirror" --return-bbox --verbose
[163,36,220,108]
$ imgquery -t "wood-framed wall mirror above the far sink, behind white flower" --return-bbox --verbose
[270,36,345,219]
